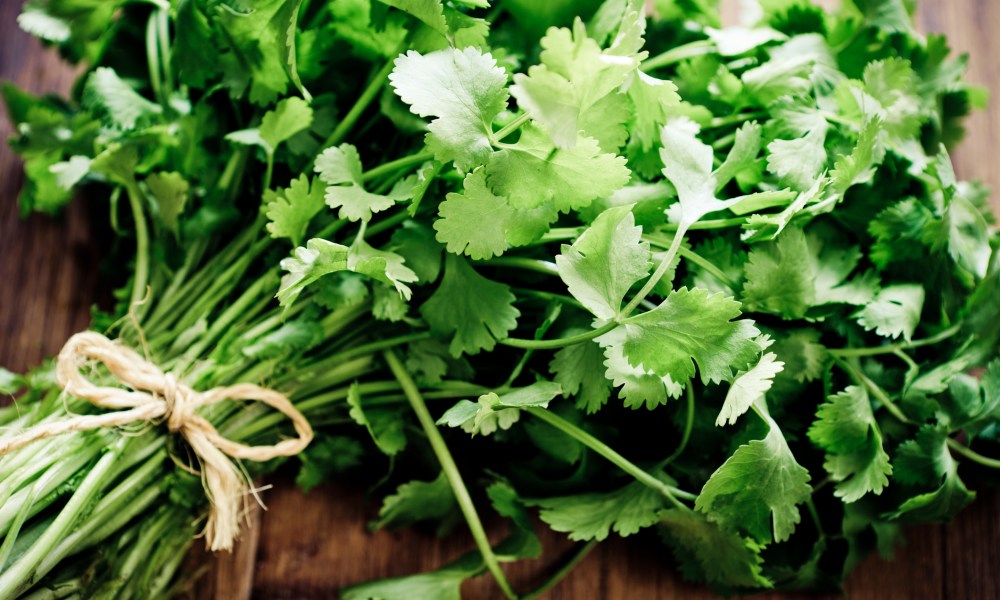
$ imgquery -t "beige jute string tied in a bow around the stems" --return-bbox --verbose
[0,331,313,550]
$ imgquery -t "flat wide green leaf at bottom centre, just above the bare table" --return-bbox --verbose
[535,482,666,541]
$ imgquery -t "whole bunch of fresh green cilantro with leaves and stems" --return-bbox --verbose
[0,0,1000,599]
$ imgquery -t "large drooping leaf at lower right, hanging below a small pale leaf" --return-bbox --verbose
[695,408,812,543]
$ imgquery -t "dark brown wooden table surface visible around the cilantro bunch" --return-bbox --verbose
[0,0,1000,600]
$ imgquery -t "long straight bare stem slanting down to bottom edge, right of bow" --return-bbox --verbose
[383,350,517,600]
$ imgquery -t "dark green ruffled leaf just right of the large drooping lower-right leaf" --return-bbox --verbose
[809,386,892,503]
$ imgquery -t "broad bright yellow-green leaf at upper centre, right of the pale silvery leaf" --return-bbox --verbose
[486,125,630,213]
